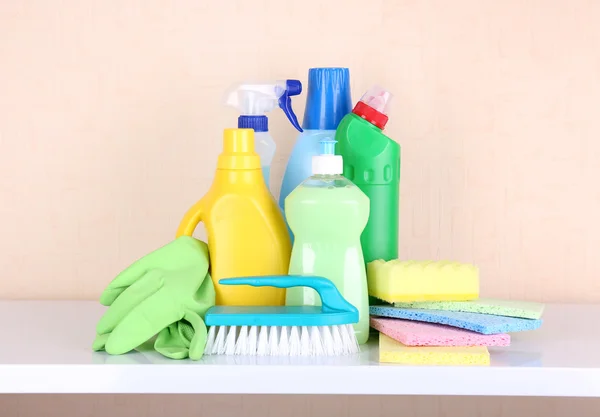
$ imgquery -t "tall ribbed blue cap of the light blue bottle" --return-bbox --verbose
[302,68,352,130]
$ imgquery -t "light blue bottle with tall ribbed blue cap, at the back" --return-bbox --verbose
[279,68,352,240]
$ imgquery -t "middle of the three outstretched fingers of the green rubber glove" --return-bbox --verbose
[96,270,164,334]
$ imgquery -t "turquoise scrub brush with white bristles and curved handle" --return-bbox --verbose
[204,275,360,356]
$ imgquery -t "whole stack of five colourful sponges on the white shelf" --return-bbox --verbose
[367,260,544,365]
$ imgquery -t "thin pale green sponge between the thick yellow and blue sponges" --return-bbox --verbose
[394,298,544,320]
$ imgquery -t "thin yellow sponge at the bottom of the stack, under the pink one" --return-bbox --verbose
[379,333,490,365]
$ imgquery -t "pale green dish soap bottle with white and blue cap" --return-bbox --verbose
[284,138,369,344]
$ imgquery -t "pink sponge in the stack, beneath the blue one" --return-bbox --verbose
[371,317,510,346]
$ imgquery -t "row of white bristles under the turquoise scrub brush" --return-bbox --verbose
[204,324,360,356]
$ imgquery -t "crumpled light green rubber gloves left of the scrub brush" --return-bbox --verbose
[93,236,215,360]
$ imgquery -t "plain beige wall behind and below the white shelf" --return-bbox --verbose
[0,0,600,416]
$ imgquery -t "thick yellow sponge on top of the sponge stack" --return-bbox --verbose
[367,259,479,303]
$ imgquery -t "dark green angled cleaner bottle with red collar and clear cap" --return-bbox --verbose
[335,86,400,263]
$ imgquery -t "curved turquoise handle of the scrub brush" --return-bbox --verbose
[219,275,358,314]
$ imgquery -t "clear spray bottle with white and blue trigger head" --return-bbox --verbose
[225,80,302,188]
